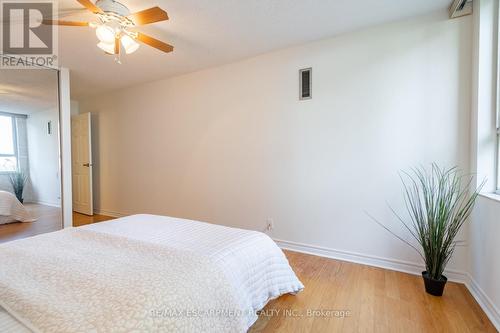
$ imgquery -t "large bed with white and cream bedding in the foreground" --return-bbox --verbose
[0,215,304,332]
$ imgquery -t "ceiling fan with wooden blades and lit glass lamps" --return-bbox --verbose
[42,0,174,62]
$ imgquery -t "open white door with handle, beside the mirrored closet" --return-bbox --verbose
[71,113,94,215]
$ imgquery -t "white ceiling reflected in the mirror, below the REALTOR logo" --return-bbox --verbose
[0,69,59,114]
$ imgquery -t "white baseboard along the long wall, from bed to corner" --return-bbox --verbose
[274,239,469,284]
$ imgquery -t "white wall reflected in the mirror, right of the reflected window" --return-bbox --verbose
[27,109,61,207]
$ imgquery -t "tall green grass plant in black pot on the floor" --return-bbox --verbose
[372,164,484,296]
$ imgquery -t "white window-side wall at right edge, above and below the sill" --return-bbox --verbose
[469,0,500,330]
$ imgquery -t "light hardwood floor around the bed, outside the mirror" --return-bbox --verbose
[0,213,497,333]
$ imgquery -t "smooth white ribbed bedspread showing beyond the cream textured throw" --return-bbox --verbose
[0,215,303,332]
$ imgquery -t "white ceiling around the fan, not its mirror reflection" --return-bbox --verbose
[53,0,451,98]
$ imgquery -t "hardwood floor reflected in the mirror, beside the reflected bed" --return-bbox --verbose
[0,203,62,243]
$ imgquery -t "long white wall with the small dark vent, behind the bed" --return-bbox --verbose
[80,12,472,271]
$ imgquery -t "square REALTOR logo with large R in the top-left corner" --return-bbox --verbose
[0,0,57,68]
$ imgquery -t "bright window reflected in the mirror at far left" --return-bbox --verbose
[0,114,18,172]
